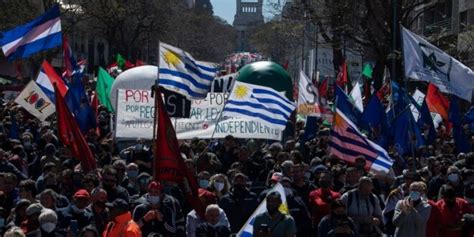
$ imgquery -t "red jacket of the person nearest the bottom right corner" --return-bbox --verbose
[436,198,472,237]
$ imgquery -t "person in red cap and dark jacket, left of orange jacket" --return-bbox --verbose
[57,189,92,230]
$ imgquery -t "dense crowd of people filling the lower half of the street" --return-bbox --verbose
[0,100,474,237]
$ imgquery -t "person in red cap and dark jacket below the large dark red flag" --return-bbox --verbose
[133,181,186,236]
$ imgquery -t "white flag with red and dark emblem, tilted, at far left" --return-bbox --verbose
[15,80,56,121]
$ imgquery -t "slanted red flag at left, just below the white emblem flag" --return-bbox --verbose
[54,84,97,172]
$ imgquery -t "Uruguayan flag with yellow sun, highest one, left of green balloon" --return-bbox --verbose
[159,43,217,99]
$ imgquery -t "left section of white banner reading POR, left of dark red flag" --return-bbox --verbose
[115,89,155,139]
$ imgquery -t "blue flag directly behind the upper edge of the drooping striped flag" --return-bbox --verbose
[361,95,389,148]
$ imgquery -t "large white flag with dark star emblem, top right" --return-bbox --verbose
[402,27,474,101]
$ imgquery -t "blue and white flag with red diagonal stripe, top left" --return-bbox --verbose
[0,5,61,61]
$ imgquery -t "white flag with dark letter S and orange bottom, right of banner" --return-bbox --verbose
[298,71,321,117]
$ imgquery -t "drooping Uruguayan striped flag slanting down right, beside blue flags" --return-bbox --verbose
[329,109,393,173]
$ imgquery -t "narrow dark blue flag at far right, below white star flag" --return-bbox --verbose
[448,95,471,153]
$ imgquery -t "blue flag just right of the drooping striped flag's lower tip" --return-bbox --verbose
[392,109,425,155]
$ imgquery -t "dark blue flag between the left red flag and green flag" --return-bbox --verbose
[64,73,97,134]
